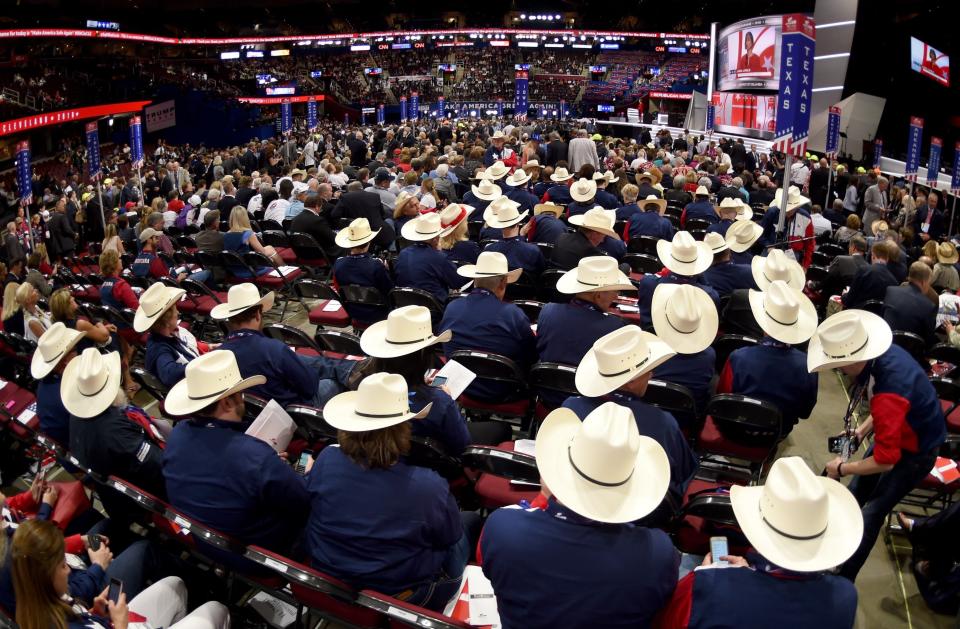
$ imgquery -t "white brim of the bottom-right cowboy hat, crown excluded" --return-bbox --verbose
[736,476,863,572]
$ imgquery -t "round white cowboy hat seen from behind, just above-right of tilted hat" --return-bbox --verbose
[650,284,720,354]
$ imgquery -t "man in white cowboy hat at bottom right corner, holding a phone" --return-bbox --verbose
[659,456,863,629]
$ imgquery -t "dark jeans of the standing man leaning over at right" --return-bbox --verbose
[840,446,939,581]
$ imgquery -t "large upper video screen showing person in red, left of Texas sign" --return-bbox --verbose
[717,15,783,90]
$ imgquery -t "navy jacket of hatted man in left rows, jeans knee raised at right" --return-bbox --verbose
[220,330,320,407]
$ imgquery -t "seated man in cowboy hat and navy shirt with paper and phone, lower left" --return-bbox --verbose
[163,350,312,570]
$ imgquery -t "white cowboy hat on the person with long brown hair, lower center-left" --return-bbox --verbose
[323,373,433,432]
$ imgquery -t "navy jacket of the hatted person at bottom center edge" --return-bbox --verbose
[478,499,679,629]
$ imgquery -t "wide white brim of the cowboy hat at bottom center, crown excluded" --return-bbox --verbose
[535,408,670,524]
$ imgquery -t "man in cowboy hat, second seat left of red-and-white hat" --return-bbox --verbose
[333,218,393,327]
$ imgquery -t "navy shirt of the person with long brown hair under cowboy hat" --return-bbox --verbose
[307,446,463,594]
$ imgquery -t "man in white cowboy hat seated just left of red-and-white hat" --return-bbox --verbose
[394,212,463,304]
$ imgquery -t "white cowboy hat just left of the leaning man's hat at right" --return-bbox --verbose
[749,280,817,345]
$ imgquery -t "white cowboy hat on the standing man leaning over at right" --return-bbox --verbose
[807,310,893,372]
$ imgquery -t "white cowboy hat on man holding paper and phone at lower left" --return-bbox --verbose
[163,349,267,416]
